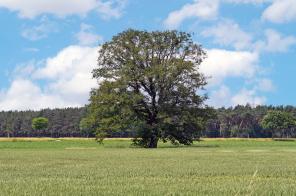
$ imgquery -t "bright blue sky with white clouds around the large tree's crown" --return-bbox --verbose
[0,0,296,110]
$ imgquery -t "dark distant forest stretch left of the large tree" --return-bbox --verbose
[0,108,87,137]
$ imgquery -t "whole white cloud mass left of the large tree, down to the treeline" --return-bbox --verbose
[0,46,98,110]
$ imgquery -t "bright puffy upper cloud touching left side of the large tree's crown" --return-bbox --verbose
[32,46,98,104]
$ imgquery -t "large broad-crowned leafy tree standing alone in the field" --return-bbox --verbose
[88,30,212,148]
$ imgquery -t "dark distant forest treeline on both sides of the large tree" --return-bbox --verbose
[0,105,296,138]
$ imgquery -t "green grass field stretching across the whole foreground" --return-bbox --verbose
[0,139,296,196]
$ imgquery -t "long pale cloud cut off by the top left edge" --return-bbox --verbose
[0,0,125,19]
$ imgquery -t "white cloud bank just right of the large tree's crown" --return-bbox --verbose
[200,49,275,107]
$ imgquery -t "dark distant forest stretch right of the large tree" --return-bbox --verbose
[202,105,296,138]
